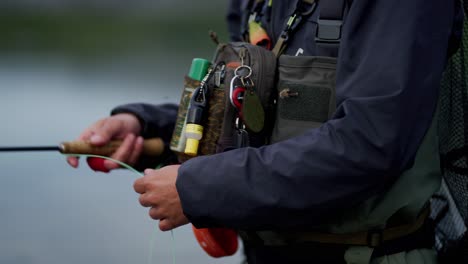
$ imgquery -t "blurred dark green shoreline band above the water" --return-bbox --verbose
[0,4,227,57]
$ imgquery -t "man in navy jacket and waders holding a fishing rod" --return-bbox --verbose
[68,0,459,264]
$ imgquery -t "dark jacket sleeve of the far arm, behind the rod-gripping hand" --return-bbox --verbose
[111,103,178,168]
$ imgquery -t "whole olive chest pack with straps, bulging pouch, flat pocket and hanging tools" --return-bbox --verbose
[171,0,345,162]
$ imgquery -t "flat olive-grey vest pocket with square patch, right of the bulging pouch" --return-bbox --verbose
[271,55,336,143]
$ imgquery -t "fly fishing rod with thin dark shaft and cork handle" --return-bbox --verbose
[0,138,164,156]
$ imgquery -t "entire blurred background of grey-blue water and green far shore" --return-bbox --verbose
[0,0,242,264]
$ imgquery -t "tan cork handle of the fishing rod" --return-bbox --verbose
[59,138,164,156]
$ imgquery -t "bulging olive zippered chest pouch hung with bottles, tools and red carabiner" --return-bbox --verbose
[171,42,276,162]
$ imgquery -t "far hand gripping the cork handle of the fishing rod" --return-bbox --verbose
[67,114,143,170]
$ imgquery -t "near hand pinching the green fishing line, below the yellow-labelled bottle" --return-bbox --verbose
[133,165,189,231]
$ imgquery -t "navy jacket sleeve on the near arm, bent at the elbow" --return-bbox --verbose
[177,0,454,230]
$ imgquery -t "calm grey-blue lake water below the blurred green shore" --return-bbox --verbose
[0,53,242,264]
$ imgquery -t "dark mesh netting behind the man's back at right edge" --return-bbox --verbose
[439,11,468,224]
